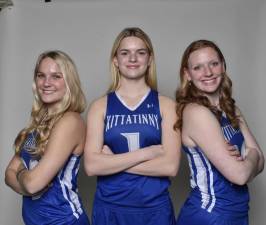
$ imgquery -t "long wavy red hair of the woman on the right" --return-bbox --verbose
[175,40,239,129]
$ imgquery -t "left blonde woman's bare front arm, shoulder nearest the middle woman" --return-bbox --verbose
[14,112,85,195]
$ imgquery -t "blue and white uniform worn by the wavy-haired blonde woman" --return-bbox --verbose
[20,132,90,225]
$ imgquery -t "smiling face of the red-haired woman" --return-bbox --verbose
[185,47,224,95]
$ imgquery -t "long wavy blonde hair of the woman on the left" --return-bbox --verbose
[14,50,86,156]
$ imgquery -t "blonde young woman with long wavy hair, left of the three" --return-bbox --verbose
[5,51,89,225]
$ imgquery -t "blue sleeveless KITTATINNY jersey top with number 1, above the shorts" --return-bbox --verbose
[95,90,170,209]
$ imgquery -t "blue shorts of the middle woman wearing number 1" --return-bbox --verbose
[92,202,175,225]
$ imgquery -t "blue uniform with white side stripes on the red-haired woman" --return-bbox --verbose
[177,114,249,225]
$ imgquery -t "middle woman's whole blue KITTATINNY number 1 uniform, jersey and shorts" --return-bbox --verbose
[92,90,175,225]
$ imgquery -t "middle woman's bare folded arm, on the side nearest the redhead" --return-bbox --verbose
[127,96,181,177]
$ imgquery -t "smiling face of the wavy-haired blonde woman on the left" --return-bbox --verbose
[36,57,66,109]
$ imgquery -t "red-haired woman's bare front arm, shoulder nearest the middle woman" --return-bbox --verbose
[182,104,259,185]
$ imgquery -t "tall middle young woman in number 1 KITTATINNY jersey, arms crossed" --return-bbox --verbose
[84,28,180,225]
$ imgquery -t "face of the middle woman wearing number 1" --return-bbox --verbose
[114,36,151,79]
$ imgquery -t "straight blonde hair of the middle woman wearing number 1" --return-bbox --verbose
[108,27,157,92]
